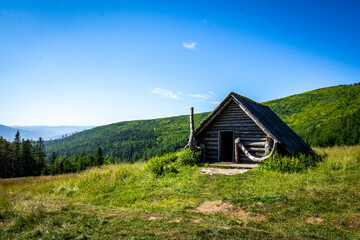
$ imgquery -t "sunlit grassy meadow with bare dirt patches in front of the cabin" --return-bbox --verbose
[0,146,360,239]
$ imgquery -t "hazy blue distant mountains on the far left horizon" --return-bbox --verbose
[0,124,94,141]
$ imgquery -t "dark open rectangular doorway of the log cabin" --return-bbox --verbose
[218,131,234,162]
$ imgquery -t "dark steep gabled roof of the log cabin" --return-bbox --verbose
[195,92,311,153]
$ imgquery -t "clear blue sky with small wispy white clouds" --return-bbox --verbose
[0,0,360,125]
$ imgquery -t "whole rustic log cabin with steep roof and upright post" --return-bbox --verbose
[187,92,311,163]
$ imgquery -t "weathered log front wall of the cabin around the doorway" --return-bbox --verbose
[195,100,267,162]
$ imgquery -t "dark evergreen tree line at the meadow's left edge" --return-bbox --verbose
[0,131,114,178]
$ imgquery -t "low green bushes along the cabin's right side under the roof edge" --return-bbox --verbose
[260,151,323,173]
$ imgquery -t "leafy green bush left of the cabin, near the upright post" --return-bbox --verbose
[146,153,177,176]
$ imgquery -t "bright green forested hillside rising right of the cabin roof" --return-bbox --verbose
[264,84,360,146]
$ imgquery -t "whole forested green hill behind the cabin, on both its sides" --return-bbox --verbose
[46,85,360,161]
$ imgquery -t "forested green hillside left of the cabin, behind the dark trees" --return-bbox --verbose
[46,113,209,162]
